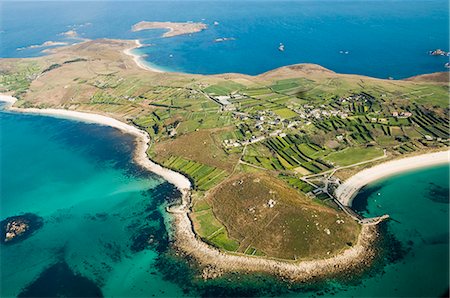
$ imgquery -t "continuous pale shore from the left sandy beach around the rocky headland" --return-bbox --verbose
[0,94,378,282]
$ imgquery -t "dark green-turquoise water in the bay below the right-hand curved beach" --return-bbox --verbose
[346,165,450,297]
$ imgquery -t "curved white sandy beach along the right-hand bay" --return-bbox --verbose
[336,151,450,206]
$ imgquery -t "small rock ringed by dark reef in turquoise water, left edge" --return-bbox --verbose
[0,213,44,244]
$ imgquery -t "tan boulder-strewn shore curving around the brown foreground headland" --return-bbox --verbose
[170,191,379,282]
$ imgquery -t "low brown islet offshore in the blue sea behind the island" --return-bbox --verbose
[131,21,207,37]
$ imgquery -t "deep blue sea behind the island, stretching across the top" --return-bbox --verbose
[0,0,449,78]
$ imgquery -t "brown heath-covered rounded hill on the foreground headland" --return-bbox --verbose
[208,174,359,259]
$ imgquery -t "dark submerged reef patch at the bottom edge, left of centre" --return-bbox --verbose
[18,262,103,297]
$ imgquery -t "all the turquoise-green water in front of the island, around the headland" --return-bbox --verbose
[0,106,449,297]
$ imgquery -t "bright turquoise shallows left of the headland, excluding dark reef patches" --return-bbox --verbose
[0,108,185,297]
